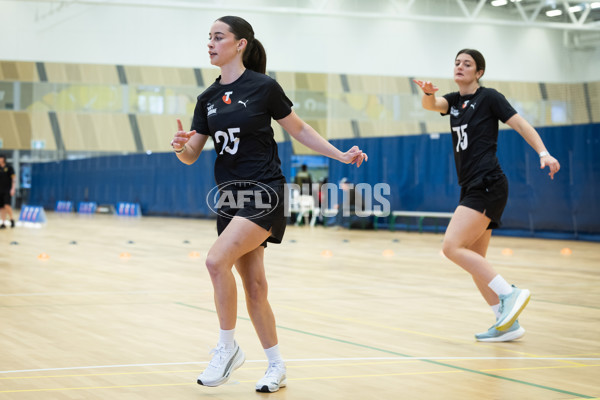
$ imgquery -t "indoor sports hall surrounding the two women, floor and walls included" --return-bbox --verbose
[0,0,600,400]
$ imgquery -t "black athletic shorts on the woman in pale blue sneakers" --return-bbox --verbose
[460,174,508,229]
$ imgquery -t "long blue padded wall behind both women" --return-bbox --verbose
[30,124,600,240]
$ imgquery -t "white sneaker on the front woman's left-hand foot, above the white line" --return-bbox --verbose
[198,342,246,386]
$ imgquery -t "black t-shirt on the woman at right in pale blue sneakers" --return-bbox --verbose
[442,87,517,187]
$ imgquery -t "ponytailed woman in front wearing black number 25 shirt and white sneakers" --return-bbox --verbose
[166,16,367,392]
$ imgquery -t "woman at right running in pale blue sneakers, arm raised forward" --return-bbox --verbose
[414,49,560,342]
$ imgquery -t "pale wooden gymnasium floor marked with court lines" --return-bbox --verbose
[0,213,600,400]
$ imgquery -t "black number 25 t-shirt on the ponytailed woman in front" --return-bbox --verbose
[192,69,292,184]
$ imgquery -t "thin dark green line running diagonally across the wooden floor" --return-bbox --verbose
[175,302,594,399]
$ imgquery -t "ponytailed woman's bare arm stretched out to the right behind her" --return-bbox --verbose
[277,111,368,167]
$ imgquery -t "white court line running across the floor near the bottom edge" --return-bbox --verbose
[0,357,600,374]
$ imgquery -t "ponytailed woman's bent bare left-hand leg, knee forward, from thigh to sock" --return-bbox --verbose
[206,217,270,330]
